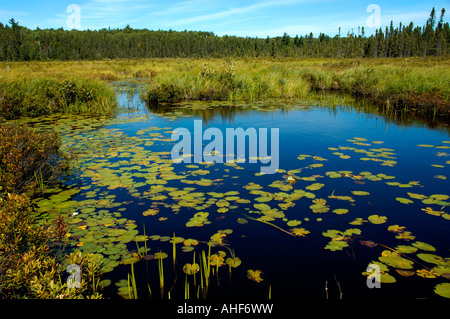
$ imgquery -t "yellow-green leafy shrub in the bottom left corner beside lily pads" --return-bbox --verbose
[0,194,101,299]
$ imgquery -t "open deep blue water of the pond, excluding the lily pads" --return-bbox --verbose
[29,84,450,299]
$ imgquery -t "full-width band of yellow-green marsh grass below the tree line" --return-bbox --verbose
[0,58,450,119]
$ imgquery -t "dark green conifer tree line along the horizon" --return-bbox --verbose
[0,8,450,61]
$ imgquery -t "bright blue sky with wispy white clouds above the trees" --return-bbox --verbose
[0,0,450,38]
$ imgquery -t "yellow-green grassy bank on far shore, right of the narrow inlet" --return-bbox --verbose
[141,59,450,118]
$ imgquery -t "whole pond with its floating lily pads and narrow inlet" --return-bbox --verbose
[25,82,450,300]
